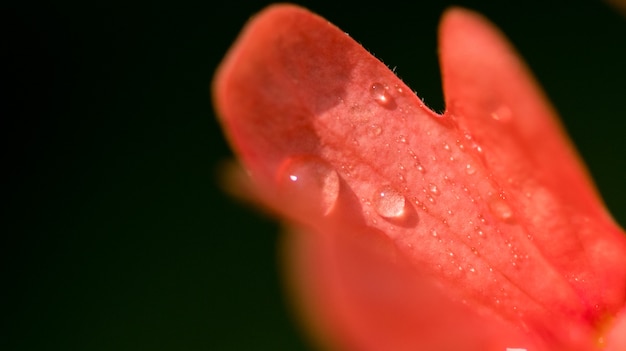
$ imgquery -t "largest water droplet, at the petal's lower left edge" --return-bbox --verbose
[277,155,340,215]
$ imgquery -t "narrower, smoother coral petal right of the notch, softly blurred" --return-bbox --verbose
[440,4,626,336]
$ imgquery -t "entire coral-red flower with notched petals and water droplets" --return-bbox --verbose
[213,4,626,351]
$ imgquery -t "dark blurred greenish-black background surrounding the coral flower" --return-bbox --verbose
[0,0,626,350]
